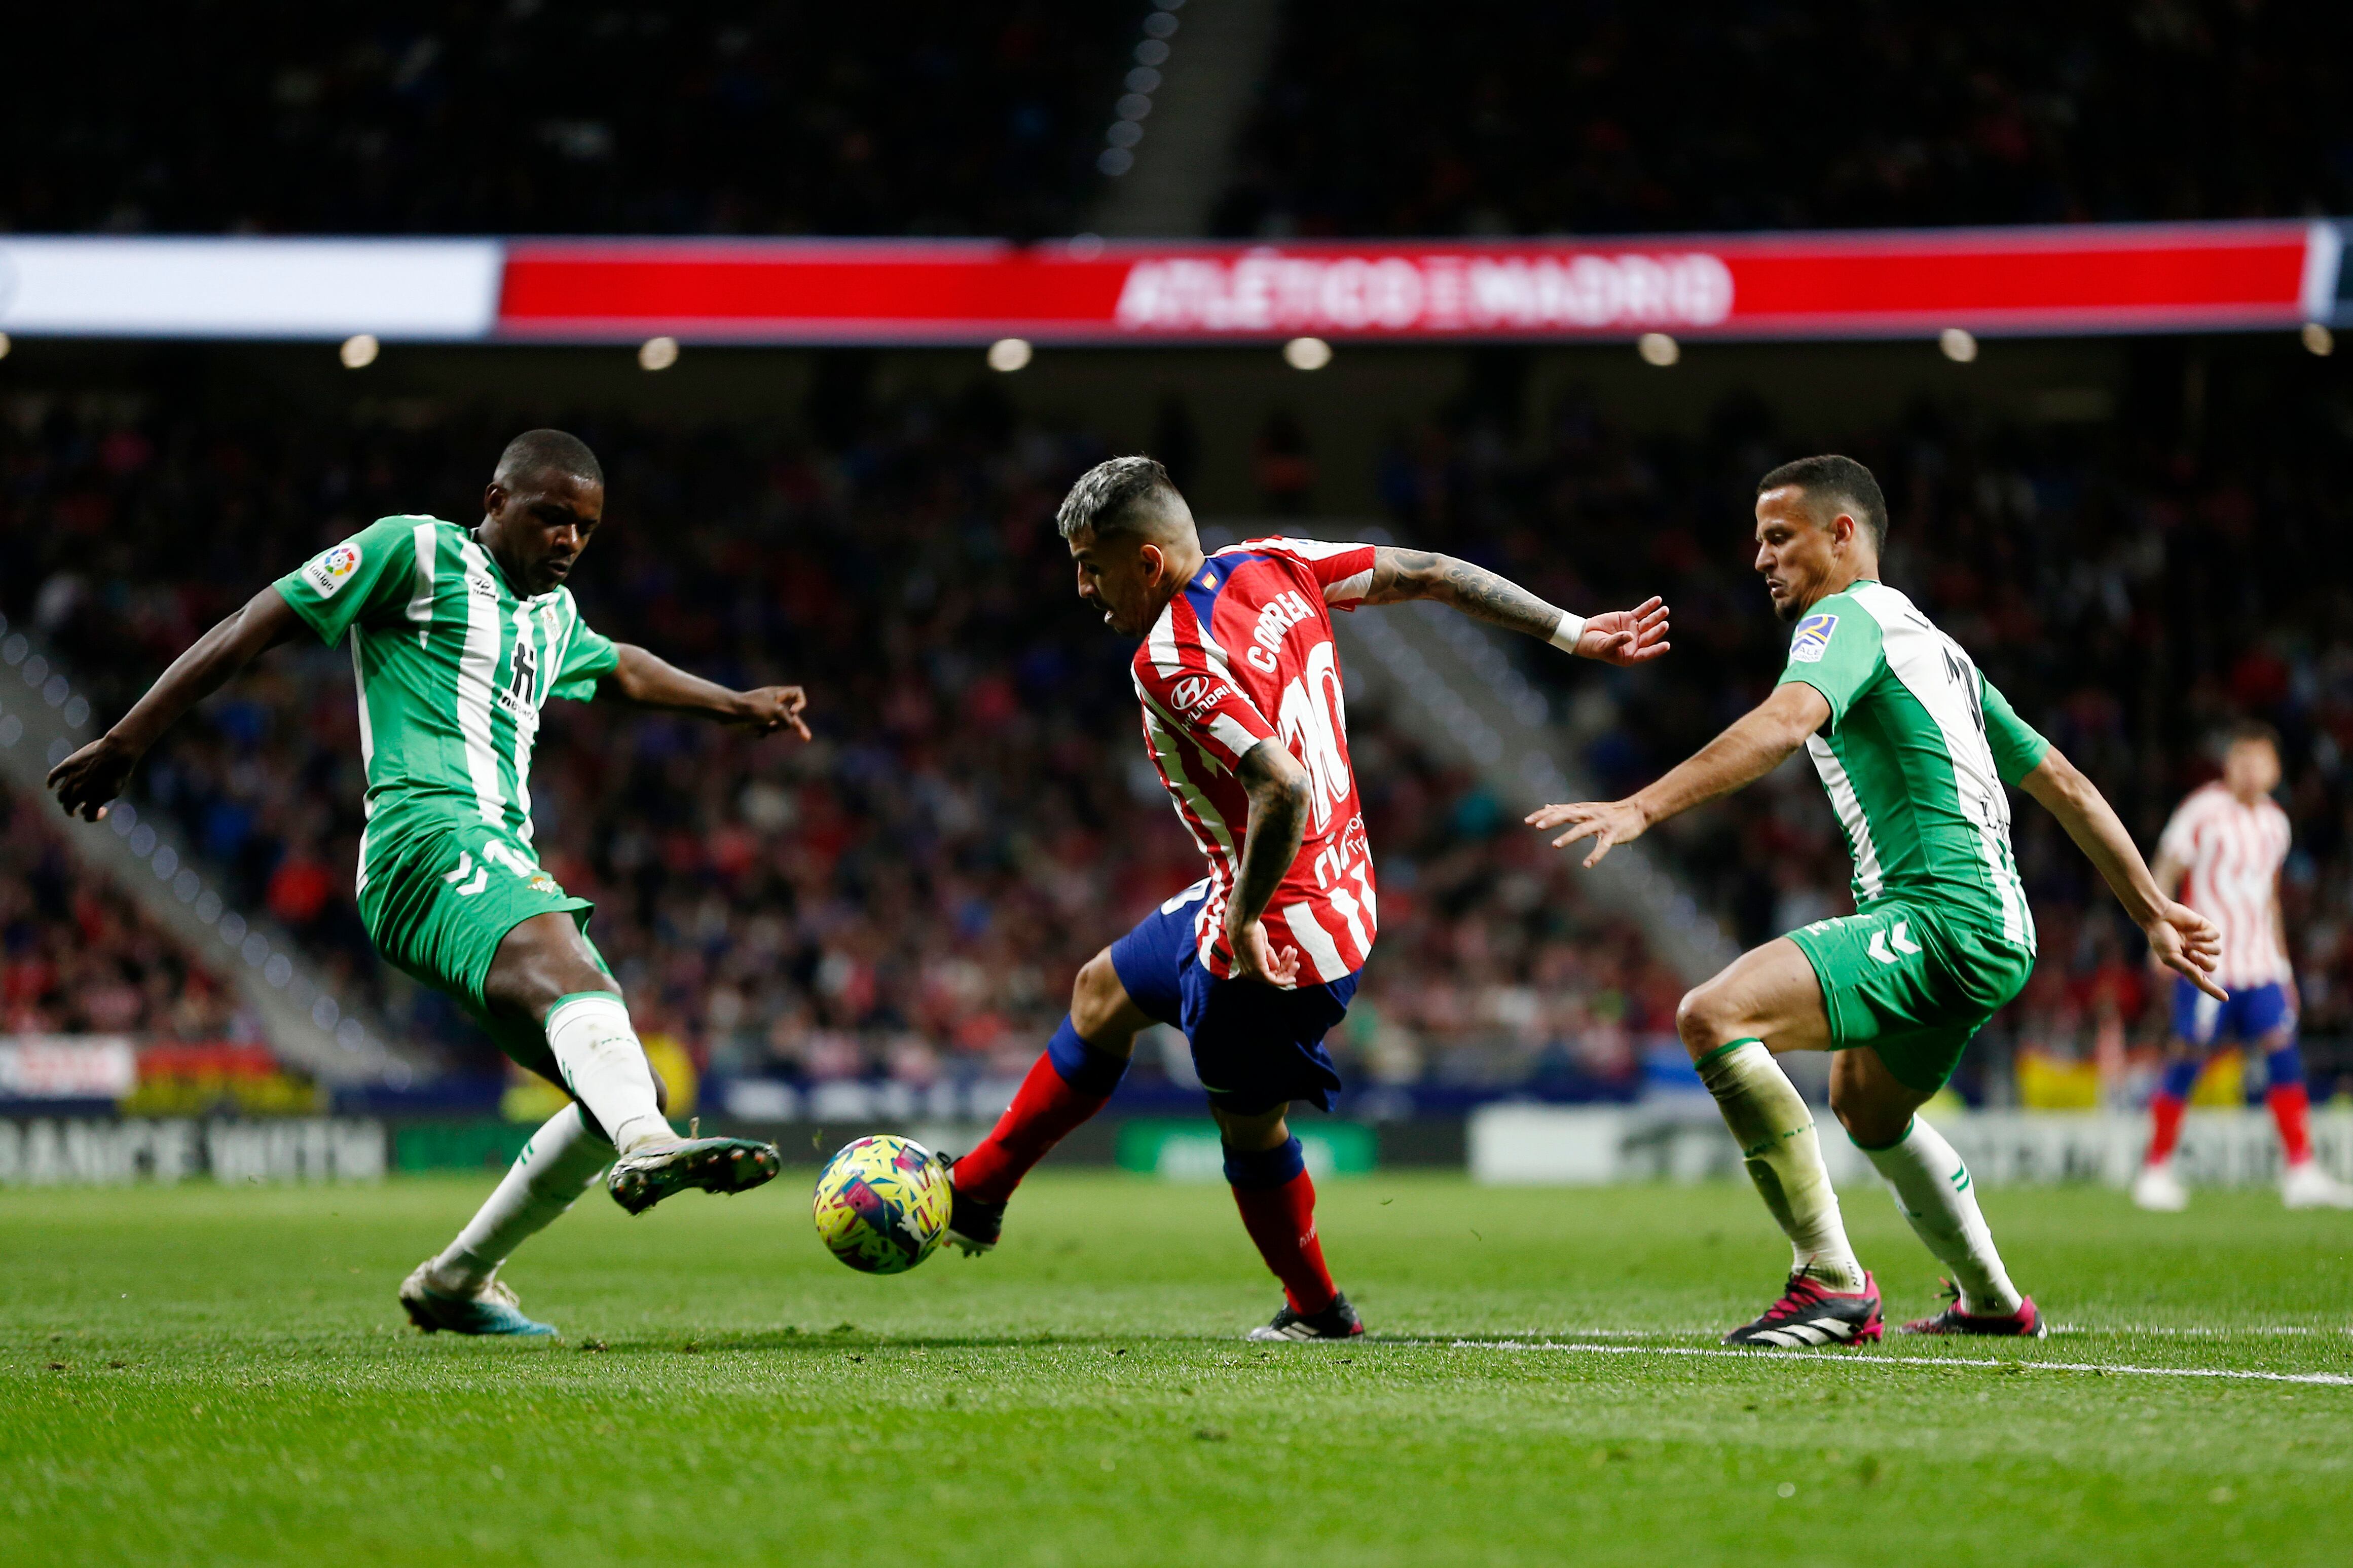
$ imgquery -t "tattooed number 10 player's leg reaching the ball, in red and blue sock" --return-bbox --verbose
[948,947,1153,1258]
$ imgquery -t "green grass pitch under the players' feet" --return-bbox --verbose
[0,1171,2353,1568]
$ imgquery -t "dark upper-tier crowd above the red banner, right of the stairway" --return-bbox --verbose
[1217,0,2353,238]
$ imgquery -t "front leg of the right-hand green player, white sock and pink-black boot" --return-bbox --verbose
[1675,938,1880,1347]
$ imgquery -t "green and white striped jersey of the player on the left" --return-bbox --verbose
[278,517,619,888]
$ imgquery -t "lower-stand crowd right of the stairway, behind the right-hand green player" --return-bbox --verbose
[1381,343,2353,1098]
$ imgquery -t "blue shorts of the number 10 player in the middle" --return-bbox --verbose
[1111,882,1357,1116]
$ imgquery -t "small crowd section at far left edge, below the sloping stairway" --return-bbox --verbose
[0,788,249,1041]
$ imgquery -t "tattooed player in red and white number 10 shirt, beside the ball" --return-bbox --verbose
[948,456,1668,1340]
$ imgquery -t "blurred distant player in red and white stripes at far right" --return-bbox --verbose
[2132,724,2353,1211]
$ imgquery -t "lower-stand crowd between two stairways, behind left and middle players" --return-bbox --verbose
[0,383,1678,1093]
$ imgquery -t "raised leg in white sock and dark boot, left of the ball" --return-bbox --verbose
[483,912,781,1213]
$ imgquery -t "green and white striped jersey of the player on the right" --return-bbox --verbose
[1781,578,2049,952]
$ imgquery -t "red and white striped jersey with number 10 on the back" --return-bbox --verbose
[1134,538,1379,983]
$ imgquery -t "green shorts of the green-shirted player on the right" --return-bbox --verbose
[1788,898,2035,1093]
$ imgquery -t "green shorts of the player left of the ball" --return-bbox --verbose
[360,818,619,1084]
